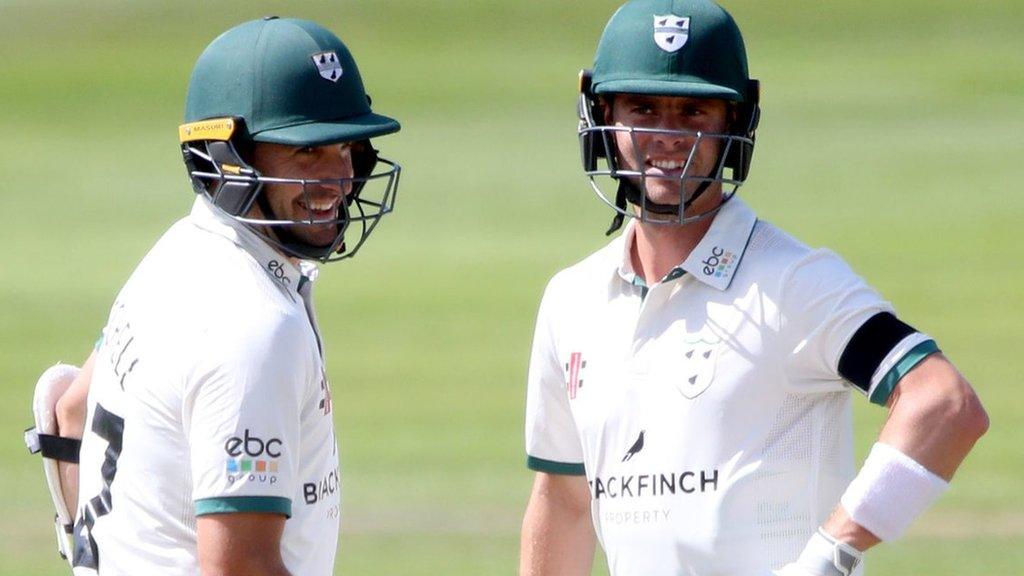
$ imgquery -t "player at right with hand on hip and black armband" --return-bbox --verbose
[520,0,988,576]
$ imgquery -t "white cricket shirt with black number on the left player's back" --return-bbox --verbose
[75,197,340,576]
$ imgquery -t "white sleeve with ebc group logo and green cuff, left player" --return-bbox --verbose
[185,313,309,517]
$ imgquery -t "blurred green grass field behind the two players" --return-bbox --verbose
[0,0,1024,576]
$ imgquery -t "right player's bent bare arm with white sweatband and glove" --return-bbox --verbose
[776,354,988,576]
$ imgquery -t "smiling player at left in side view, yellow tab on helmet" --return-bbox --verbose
[26,16,400,576]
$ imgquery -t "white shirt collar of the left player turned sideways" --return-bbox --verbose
[188,196,318,291]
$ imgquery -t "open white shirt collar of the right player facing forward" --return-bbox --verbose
[613,197,758,290]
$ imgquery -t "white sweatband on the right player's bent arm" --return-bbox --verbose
[840,442,949,540]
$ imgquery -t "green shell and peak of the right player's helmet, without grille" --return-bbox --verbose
[593,0,750,102]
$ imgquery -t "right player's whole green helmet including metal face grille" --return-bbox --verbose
[579,0,761,234]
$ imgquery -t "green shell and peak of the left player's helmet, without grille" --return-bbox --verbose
[184,16,399,146]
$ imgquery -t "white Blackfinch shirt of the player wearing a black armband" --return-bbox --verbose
[526,198,934,576]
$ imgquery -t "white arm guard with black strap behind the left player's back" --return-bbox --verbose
[25,364,81,562]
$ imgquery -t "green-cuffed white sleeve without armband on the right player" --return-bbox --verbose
[526,281,584,476]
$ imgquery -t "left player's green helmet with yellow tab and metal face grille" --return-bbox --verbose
[178,16,401,261]
